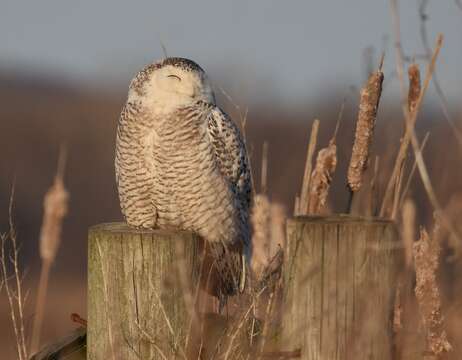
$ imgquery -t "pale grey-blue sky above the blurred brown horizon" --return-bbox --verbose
[0,0,462,102]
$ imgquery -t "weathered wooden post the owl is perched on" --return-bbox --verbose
[87,223,201,360]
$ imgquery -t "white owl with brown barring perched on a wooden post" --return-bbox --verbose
[115,58,251,304]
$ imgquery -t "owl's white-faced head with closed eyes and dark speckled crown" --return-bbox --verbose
[128,57,215,113]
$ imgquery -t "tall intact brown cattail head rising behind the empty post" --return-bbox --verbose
[348,65,383,192]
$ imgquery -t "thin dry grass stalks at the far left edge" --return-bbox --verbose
[0,186,29,360]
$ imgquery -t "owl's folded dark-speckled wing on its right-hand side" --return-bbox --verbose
[207,107,252,215]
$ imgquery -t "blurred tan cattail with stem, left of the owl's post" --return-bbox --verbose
[30,150,69,353]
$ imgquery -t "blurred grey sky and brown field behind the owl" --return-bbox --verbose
[0,0,462,358]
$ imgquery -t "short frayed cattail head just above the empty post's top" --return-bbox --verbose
[308,139,337,214]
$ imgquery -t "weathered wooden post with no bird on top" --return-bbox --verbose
[282,216,401,360]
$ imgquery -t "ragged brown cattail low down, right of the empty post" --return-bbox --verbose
[414,223,452,357]
